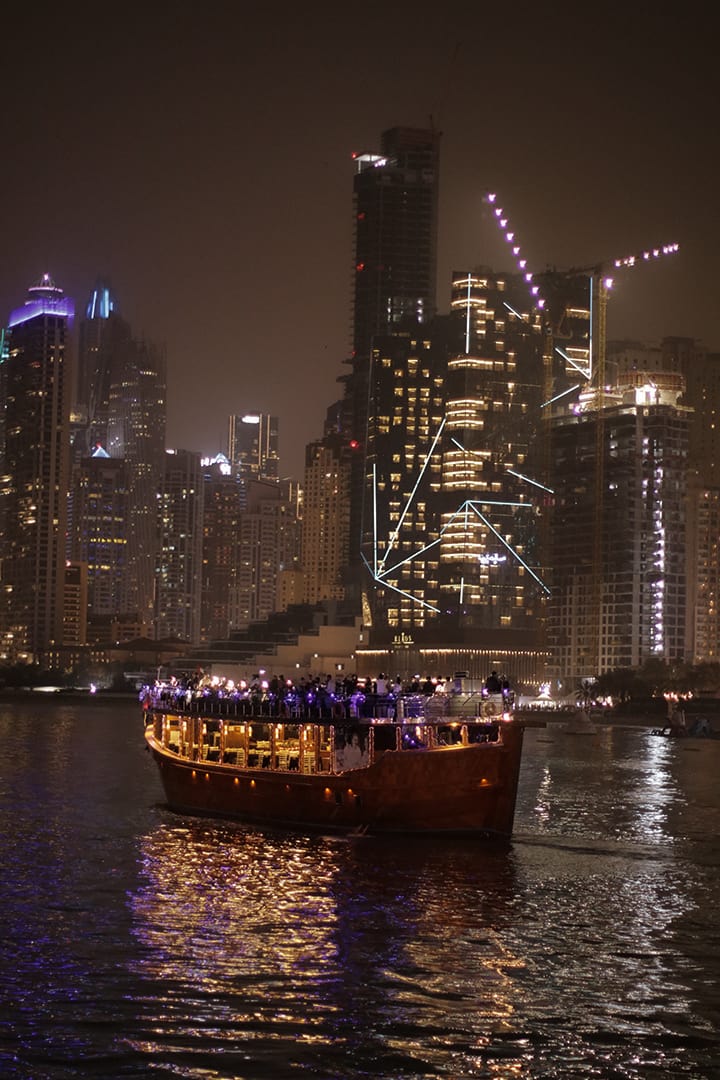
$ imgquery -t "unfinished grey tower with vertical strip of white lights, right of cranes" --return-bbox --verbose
[548,372,691,684]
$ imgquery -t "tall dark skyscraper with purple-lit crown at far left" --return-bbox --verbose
[0,274,73,663]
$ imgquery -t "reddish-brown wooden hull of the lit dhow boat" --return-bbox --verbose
[146,721,524,840]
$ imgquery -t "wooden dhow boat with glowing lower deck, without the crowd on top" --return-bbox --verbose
[142,687,525,840]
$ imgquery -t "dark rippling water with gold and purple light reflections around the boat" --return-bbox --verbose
[0,707,720,1080]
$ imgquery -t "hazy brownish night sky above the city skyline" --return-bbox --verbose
[0,2,720,478]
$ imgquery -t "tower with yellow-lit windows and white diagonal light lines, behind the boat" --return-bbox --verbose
[364,269,547,677]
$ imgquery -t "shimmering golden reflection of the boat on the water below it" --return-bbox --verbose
[127,819,524,1076]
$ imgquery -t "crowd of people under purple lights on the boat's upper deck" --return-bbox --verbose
[140,671,510,719]
